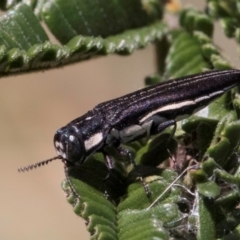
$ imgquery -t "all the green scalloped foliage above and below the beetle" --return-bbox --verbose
[4,0,240,240]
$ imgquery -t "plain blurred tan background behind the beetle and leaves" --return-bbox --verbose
[0,0,239,240]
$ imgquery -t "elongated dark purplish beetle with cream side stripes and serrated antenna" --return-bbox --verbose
[18,69,240,195]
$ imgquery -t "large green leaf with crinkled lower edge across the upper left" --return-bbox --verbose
[0,0,167,75]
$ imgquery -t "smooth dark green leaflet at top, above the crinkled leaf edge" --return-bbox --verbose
[43,0,163,43]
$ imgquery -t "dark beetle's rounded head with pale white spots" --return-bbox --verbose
[54,130,84,163]
